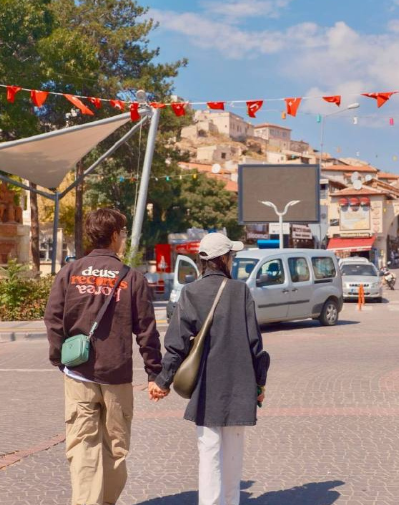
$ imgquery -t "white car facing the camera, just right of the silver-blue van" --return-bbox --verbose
[340,261,382,302]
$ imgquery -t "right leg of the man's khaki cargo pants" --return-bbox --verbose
[101,384,133,503]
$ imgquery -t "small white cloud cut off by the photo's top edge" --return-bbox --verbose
[202,0,292,22]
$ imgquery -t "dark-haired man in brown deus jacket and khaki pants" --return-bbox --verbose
[44,209,161,505]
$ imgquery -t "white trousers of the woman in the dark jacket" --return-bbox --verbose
[197,426,245,505]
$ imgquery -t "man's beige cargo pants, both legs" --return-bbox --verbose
[65,376,133,505]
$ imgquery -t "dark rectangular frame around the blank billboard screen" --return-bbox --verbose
[238,163,320,225]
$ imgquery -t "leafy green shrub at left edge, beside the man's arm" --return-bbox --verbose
[0,260,54,321]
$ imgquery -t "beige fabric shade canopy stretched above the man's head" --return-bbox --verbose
[0,113,130,189]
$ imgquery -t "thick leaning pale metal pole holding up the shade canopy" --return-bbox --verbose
[130,109,160,260]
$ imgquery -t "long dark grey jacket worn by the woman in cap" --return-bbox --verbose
[156,270,270,426]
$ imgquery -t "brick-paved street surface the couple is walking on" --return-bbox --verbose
[0,291,399,505]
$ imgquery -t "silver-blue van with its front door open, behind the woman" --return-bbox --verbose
[166,249,343,326]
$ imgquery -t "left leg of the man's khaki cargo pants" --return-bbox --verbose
[65,376,103,505]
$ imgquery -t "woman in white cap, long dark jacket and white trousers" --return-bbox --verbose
[154,233,270,505]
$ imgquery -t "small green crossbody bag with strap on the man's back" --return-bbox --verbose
[61,265,130,368]
